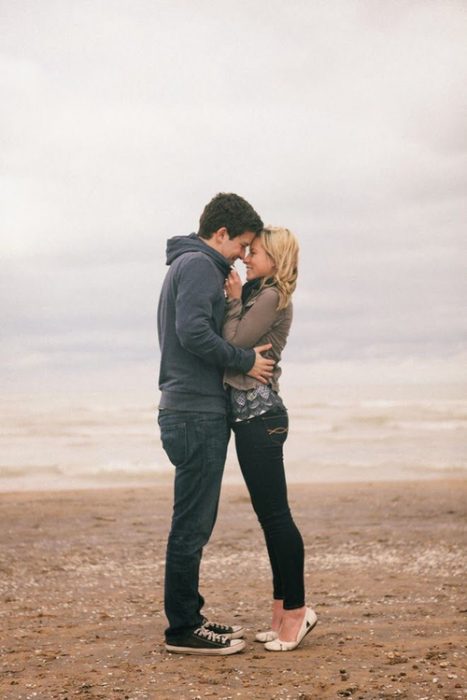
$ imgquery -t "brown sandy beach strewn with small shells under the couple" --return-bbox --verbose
[0,480,467,700]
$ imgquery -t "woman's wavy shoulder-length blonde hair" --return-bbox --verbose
[259,226,299,311]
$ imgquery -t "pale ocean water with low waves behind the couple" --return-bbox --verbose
[0,386,467,491]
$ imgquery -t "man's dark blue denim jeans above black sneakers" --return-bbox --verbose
[158,410,230,641]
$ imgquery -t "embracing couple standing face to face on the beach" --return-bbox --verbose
[158,194,317,655]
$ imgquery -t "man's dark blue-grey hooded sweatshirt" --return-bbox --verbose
[157,233,256,413]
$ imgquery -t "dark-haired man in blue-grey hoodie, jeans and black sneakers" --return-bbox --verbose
[158,194,273,655]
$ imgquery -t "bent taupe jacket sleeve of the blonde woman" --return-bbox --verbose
[222,288,279,348]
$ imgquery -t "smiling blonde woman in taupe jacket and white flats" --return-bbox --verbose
[223,227,317,651]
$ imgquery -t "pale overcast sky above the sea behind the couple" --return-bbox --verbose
[0,0,467,388]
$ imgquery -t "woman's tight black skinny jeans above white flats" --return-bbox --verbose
[232,412,305,610]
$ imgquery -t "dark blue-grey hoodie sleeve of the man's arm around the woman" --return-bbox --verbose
[175,256,256,373]
